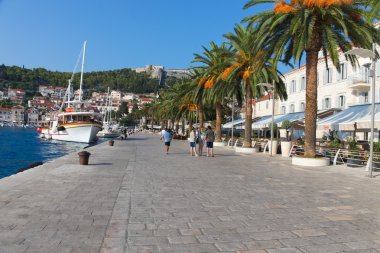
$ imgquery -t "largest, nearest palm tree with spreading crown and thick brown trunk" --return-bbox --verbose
[244,0,379,157]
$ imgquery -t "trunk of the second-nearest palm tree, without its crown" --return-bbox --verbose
[243,82,253,148]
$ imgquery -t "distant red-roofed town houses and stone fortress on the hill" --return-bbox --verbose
[0,65,189,126]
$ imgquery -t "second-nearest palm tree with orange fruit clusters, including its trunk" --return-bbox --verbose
[222,25,286,148]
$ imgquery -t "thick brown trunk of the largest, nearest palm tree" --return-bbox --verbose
[305,50,318,157]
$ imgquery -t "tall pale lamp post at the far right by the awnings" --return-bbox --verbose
[345,43,376,177]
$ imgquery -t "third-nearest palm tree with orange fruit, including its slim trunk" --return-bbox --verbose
[193,42,241,142]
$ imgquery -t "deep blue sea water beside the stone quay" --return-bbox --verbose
[0,127,96,178]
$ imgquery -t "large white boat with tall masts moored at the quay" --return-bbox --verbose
[37,42,103,143]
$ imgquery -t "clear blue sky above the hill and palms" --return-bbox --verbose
[0,0,290,72]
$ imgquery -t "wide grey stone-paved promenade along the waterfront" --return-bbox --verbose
[0,133,380,253]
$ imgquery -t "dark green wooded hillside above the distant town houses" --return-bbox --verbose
[0,65,175,96]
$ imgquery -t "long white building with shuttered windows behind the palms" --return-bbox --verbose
[254,41,380,140]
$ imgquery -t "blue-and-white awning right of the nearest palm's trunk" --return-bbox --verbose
[317,104,380,131]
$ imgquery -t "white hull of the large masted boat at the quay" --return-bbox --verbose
[50,124,102,143]
